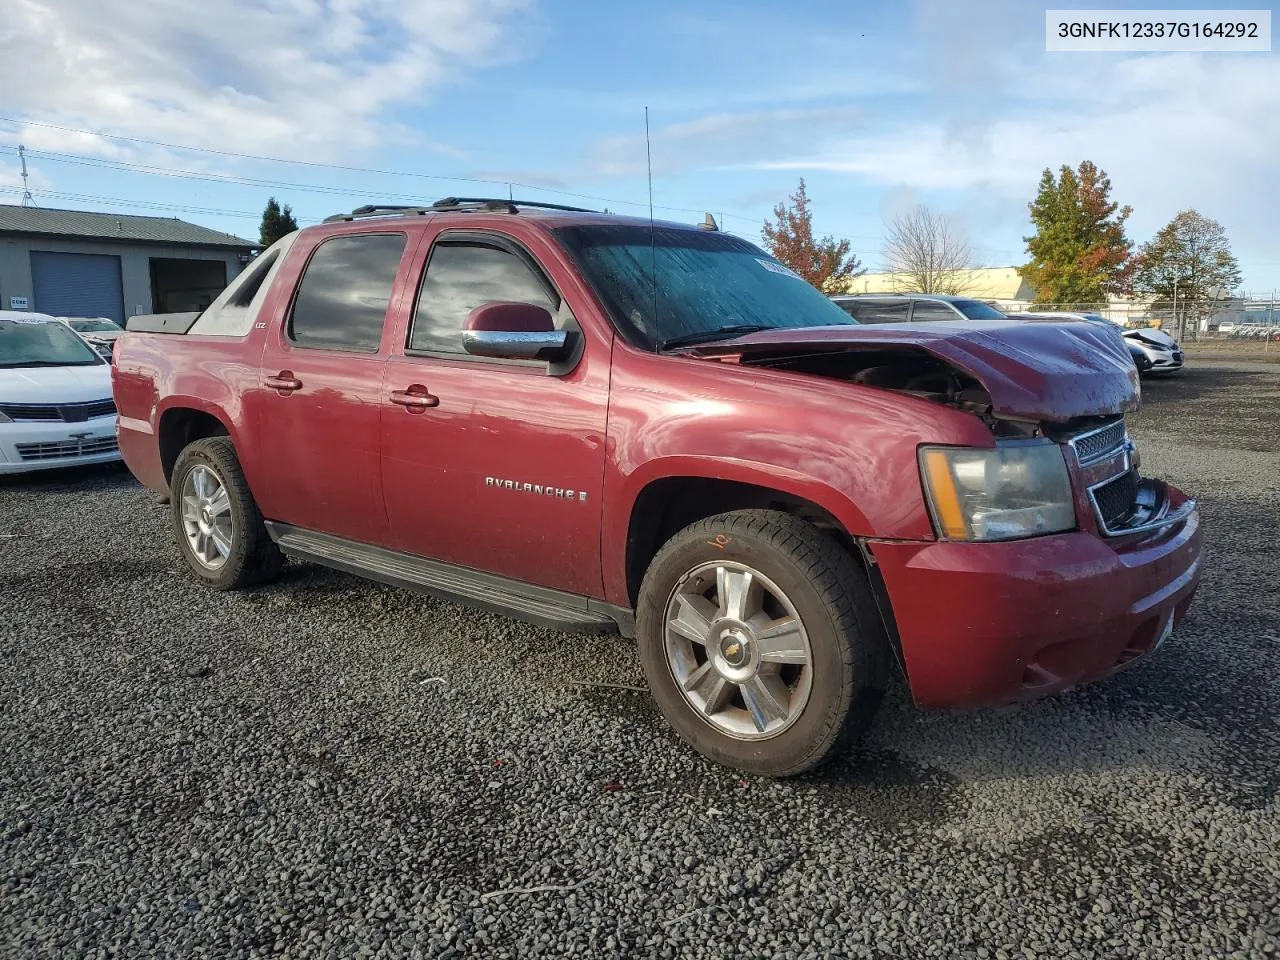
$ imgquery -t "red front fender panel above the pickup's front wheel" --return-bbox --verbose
[602,343,995,605]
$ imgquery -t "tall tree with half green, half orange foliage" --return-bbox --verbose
[1019,160,1134,303]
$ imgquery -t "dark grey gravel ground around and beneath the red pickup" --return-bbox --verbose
[0,361,1280,959]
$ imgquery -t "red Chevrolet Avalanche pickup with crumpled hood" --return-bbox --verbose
[114,198,1201,776]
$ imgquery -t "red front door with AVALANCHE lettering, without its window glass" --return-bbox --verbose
[379,216,613,598]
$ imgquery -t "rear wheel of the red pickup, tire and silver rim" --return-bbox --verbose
[169,436,284,590]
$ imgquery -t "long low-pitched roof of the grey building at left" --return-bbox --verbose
[0,204,259,250]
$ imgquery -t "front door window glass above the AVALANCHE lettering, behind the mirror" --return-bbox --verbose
[408,239,559,353]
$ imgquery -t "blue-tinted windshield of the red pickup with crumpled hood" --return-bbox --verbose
[556,224,856,349]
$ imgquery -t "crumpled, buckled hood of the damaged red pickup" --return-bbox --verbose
[687,320,1138,422]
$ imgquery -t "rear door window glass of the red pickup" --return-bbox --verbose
[289,233,404,353]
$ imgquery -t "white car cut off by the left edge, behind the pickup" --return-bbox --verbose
[0,310,120,475]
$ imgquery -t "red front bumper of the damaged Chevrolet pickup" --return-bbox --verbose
[868,491,1201,707]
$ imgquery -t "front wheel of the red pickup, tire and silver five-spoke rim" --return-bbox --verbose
[636,509,888,777]
